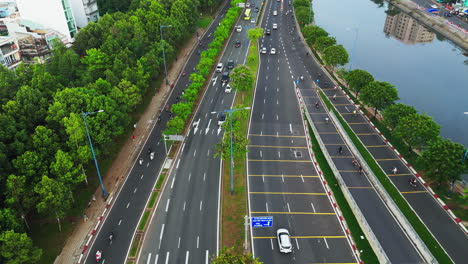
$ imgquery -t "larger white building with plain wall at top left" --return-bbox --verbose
[16,0,77,42]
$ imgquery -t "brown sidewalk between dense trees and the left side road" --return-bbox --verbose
[54,26,205,264]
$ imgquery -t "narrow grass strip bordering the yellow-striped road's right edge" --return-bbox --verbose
[308,124,379,263]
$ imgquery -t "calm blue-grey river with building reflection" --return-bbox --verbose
[313,0,468,146]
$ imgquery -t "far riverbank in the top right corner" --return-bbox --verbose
[386,0,468,52]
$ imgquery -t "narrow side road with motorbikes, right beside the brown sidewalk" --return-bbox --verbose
[85,3,234,263]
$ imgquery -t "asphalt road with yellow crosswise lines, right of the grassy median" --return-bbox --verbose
[247,0,357,264]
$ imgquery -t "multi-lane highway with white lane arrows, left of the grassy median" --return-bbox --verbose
[135,1,266,264]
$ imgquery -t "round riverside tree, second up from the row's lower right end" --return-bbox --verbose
[393,114,440,150]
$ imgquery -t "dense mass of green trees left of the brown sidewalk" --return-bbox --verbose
[0,0,227,263]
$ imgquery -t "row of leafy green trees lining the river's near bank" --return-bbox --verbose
[294,7,466,188]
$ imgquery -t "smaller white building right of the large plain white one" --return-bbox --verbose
[70,0,99,28]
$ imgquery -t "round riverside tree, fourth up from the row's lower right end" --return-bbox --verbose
[361,81,399,115]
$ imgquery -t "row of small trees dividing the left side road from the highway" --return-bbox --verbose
[164,0,242,135]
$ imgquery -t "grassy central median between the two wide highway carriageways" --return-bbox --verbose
[222,38,258,250]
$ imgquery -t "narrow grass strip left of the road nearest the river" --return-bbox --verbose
[320,91,452,263]
